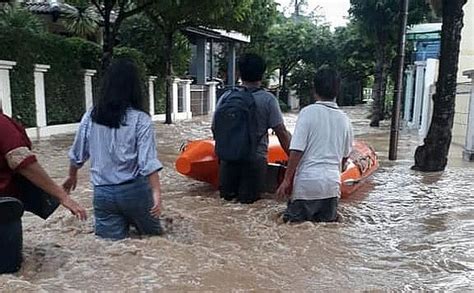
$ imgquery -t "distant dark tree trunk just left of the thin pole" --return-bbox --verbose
[370,43,386,127]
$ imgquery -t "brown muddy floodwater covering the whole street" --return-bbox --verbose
[0,107,474,292]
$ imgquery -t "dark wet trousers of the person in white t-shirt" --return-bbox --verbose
[283,197,339,223]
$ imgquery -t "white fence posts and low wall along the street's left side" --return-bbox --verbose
[0,60,216,139]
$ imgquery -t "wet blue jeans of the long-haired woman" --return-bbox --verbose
[94,177,163,240]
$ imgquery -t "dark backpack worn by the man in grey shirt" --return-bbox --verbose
[213,88,261,161]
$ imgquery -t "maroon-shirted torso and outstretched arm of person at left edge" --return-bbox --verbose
[0,108,86,220]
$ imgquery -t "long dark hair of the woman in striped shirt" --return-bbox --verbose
[92,58,145,128]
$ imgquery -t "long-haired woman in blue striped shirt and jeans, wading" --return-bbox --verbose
[64,59,163,240]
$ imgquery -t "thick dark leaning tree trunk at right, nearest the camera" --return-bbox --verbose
[412,0,467,172]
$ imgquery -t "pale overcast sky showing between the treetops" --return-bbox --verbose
[276,0,350,27]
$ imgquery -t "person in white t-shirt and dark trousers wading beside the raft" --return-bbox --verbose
[277,68,353,222]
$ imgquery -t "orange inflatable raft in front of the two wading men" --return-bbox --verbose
[176,136,378,198]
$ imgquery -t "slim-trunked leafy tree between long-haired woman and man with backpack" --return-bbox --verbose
[146,0,252,124]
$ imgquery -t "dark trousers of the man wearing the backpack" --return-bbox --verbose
[219,158,267,203]
